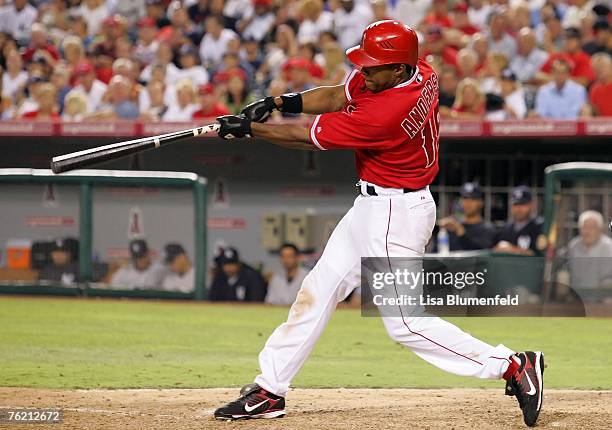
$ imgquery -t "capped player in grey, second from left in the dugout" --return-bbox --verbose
[110,239,166,290]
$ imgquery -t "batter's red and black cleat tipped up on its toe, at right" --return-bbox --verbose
[504,351,544,427]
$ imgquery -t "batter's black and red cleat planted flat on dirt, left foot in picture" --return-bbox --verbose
[215,384,285,420]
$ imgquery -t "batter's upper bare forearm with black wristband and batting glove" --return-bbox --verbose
[240,85,347,122]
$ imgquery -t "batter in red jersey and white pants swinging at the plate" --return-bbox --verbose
[214,20,544,426]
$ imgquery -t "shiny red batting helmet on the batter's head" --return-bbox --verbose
[346,19,419,68]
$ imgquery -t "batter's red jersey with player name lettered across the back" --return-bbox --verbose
[310,59,440,189]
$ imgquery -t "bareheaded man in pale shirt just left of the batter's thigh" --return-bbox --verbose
[266,243,308,305]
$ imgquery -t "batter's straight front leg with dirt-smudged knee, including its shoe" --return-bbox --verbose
[215,209,360,419]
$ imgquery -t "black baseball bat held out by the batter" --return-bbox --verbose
[51,123,219,173]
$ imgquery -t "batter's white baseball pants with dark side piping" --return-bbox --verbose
[255,189,515,396]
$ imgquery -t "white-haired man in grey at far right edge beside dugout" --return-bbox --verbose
[566,210,612,290]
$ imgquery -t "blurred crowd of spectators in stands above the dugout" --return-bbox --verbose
[0,0,612,121]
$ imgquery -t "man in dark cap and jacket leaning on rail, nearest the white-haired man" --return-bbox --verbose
[494,186,546,255]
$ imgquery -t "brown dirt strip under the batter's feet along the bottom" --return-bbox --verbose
[0,388,612,430]
